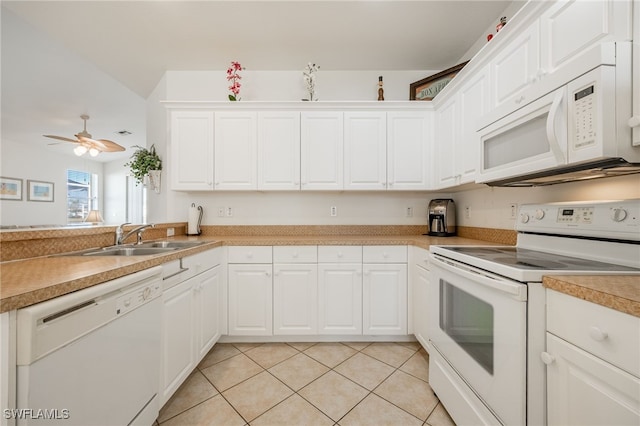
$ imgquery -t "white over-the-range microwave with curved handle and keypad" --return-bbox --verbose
[476,43,640,186]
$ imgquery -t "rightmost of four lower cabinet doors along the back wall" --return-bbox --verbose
[362,263,407,335]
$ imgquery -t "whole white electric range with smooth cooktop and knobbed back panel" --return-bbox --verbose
[428,200,640,425]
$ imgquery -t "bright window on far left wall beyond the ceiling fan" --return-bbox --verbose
[67,170,99,223]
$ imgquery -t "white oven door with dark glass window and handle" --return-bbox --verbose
[428,253,527,424]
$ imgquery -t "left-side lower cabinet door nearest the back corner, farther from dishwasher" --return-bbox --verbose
[194,265,222,362]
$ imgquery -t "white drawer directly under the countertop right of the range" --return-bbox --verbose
[547,290,640,377]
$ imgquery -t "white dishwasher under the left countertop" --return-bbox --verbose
[14,266,162,426]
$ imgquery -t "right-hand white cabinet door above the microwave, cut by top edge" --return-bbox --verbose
[540,0,632,73]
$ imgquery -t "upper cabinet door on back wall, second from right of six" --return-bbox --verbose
[344,111,387,191]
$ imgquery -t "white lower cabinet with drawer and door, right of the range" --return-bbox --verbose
[541,290,640,426]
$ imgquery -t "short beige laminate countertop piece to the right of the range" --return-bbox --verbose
[543,275,640,317]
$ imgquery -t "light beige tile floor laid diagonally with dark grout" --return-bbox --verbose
[157,342,455,426]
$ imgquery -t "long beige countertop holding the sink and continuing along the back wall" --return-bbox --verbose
[0,235,484,313]
